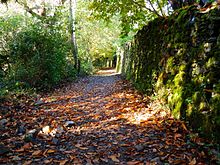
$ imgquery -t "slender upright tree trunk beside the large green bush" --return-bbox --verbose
[69,0,80,72]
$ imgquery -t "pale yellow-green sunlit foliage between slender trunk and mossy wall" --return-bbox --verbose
[76,1,120,69]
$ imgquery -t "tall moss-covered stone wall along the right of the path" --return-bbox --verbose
[118,6,220,142]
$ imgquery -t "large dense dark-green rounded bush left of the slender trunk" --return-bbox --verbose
[1,15,76,88]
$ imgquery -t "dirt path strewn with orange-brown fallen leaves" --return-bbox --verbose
[0,70,217,165]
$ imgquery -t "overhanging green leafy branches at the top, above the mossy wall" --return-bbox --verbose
[90,0,168,35]
